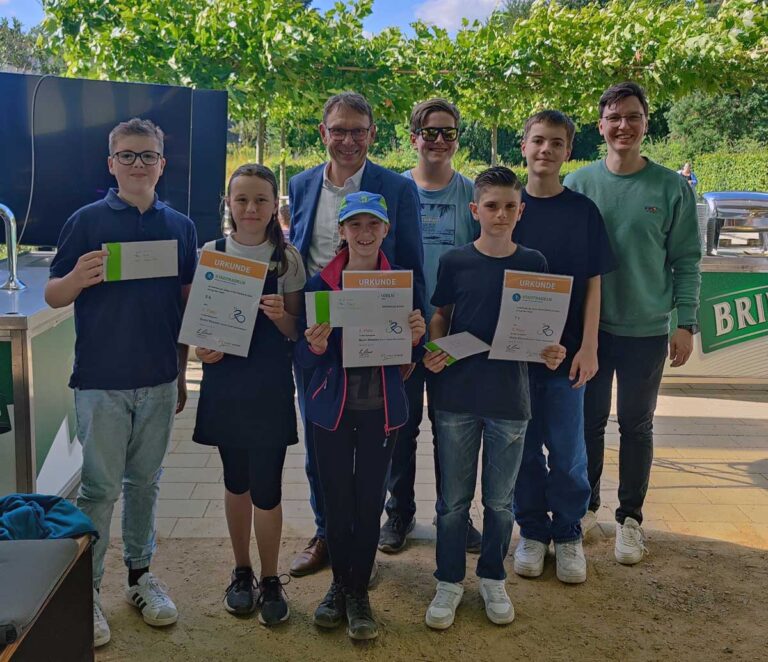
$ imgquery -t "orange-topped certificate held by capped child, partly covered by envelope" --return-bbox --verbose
[341,271,413,368]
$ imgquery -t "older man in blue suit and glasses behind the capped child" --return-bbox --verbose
[288,92,425,577]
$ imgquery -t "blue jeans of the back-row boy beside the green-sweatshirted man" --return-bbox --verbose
[515,370,591,545]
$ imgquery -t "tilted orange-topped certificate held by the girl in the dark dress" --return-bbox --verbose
[179,251,269,356]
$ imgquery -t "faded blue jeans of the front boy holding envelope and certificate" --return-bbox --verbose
[435,410,527,583]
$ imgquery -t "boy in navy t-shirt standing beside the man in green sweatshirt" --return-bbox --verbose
[514,110,615,584]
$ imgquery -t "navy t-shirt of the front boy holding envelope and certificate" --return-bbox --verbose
[432,243,548,421]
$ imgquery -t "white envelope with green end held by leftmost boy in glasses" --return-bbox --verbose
[101,239,179,282]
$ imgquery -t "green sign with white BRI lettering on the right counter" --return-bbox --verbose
[699,272,768,354]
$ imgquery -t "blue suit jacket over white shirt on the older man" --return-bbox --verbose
[288,161,426,313]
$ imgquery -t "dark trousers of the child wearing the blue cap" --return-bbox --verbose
[313,409,397,591]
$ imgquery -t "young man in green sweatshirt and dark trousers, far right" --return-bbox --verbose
[564,82,701,565]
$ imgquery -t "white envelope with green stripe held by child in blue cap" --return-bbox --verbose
[304,288,413,327]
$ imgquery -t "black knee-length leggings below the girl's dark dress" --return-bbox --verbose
[219,446,286,510]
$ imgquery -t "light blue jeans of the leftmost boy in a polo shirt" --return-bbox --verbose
[75,380,178,589]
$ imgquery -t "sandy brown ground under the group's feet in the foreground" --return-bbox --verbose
[96,528,768,662]
